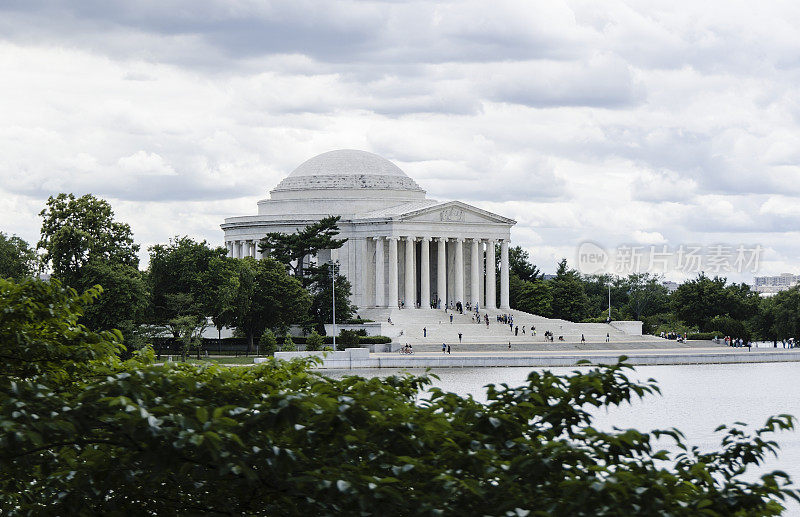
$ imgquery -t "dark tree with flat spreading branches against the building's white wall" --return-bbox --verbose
[258,216,347,285]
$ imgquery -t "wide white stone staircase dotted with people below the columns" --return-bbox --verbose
[359,308,668,351]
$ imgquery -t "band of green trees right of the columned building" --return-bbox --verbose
[509,246,800,341]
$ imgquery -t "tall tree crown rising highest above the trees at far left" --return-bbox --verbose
[37,193,139,285]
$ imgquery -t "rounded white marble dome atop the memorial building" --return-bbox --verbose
[272,149,424,193]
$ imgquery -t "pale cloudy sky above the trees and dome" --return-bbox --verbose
[0,0,800,281]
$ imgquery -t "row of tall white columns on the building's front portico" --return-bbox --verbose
[362,236,509,309]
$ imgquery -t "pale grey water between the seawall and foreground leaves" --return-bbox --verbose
[329,363,800,516]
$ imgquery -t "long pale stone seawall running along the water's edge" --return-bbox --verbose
[275,347,800,370]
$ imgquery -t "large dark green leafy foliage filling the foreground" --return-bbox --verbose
[0,280,797,515]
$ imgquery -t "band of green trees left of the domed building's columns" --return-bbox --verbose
[0,193,354,350]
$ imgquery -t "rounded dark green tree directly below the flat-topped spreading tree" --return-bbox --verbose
[232,257,311,352]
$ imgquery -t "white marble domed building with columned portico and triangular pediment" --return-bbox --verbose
[221,150,515,309]
